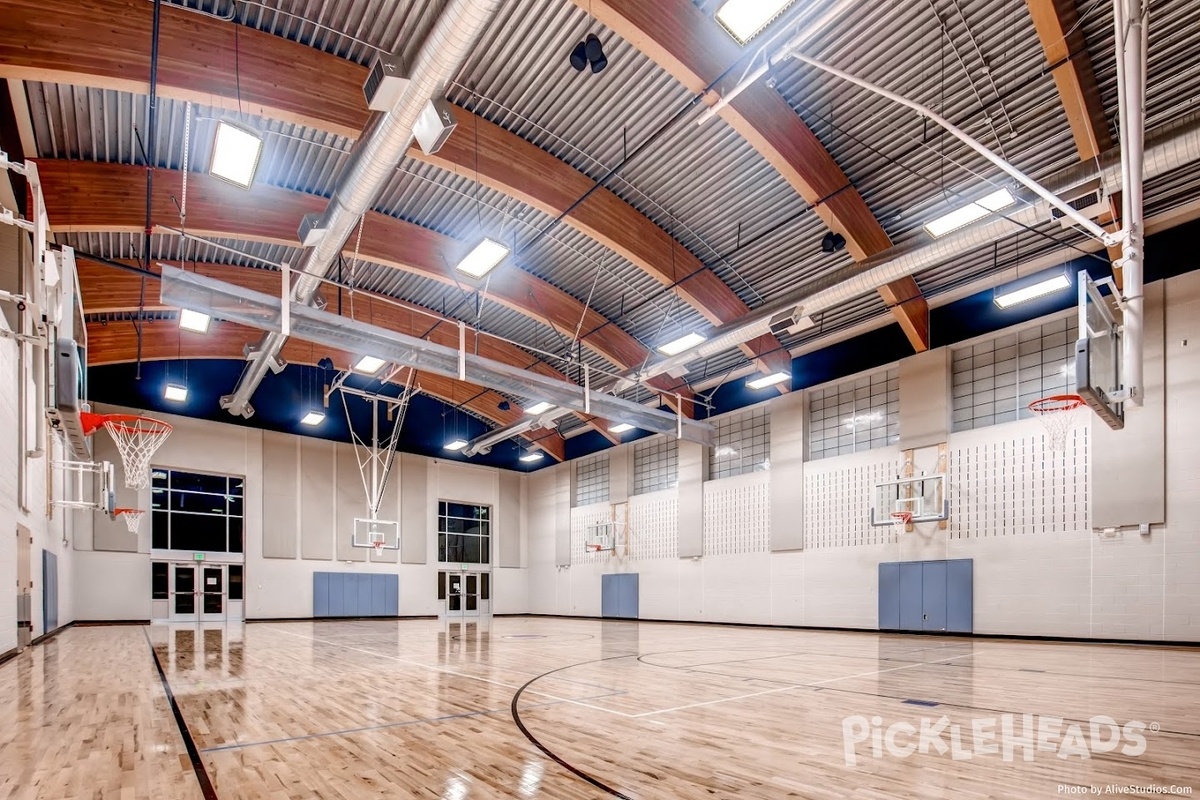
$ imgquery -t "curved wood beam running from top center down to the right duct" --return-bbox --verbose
[572,0,929,351]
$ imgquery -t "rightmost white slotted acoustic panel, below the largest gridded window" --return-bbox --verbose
[947,422,1091,539]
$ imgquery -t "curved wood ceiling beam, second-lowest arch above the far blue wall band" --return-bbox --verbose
[76,253,620,444]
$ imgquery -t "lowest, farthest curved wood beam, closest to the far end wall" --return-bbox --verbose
[88,320,566,461]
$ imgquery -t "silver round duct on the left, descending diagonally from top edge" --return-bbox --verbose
[221,0,499,417]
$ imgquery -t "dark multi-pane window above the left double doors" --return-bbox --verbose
[150,467,246,553]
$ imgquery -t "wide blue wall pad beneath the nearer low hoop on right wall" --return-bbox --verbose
[878,559,974,633]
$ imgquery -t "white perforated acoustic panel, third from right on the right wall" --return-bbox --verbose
[704,473,770,555]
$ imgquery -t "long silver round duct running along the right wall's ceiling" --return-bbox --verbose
[643,112,1200,383]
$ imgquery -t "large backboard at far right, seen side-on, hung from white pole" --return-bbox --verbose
[1075,271,1124,429]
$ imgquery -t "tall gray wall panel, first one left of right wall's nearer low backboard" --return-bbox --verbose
[770,392,808,552]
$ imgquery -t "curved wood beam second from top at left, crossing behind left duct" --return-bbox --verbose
[37,160,691,411]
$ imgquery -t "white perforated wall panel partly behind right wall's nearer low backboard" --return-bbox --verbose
[804,449,902,549]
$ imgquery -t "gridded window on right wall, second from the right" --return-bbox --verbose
[809,368,900,461]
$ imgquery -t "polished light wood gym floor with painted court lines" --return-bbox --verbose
[0,618,1200,800]
